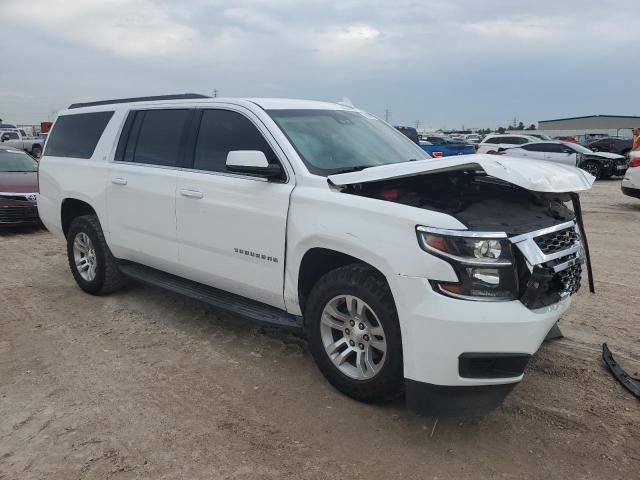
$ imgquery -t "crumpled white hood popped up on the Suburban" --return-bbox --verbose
[328,155,595,193]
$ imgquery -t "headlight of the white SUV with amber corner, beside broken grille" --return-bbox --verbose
[417,227,518,300]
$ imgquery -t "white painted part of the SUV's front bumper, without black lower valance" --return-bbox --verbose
[388,275,571,386]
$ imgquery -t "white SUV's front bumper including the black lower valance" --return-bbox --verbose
[388,276,571,417]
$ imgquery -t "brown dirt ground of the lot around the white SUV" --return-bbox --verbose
[0,181,640,480]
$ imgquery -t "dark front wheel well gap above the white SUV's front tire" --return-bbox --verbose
[298,248,384,312]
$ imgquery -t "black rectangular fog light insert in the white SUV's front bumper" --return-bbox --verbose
[458,352,531,378]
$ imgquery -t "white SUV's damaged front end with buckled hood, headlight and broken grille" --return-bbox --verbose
[329,155,593,310]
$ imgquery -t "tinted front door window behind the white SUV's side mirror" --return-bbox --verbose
[193,110,277,172]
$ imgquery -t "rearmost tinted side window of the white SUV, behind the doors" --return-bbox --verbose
[44,111,113,158]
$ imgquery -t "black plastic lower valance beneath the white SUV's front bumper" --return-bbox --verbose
[404,378,517,417]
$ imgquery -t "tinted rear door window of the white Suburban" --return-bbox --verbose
[131,110,190,167]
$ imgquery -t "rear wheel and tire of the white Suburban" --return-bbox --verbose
[67,215,126,295]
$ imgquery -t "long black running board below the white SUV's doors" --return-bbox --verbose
[120,263,302,329]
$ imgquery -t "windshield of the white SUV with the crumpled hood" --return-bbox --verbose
[267,110,430,176]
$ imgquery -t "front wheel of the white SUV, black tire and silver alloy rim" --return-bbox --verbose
[305,264,403,402]
